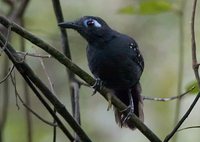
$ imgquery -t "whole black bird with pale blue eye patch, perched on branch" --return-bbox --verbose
[59,16,144,129]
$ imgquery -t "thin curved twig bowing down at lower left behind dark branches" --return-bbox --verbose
[10,75,57,126]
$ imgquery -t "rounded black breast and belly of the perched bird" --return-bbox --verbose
[87,47,140,88]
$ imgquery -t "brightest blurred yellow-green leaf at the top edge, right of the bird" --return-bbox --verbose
[139,0,172,14]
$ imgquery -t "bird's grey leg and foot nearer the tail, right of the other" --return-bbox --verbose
[122,90,134,124]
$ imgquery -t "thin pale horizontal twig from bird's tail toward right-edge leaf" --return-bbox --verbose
[143,87,195,102]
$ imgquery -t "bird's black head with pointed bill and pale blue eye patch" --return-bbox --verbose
[58,16,112,43]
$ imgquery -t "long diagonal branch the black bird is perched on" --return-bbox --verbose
[0,16,161,142]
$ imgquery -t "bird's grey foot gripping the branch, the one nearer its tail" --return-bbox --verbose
[121,105,134,124]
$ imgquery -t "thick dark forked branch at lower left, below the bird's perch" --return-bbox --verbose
[0,34,91,142]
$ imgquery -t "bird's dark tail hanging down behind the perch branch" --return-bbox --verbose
[114,83,144,130]
